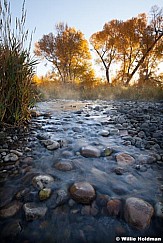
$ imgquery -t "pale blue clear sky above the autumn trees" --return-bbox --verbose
[10,0,163,76]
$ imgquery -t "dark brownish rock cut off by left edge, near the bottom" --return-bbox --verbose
[0,201,22,218]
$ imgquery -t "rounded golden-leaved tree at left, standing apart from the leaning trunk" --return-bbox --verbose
[35,23,93,82]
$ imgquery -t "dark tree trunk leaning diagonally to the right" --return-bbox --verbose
[126,32,163,85]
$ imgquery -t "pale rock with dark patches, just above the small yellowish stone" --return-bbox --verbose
[32,175,54,189]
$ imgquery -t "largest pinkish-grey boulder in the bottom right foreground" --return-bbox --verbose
[124,197,154,229]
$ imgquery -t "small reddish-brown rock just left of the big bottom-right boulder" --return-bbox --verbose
[107,199,122,216]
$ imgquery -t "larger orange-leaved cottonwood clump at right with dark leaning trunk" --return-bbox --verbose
[90,6,163,85]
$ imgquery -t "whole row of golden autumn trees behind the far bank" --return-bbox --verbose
[35,6,163,85]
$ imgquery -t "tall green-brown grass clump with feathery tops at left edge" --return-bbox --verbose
[0,0,36,125]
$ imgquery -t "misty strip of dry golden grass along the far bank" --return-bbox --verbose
[38,81,163,101]
